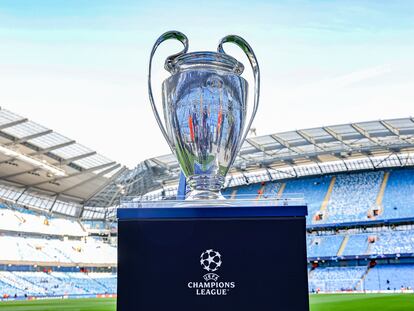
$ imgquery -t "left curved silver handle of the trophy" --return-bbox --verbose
[148,30,188,151]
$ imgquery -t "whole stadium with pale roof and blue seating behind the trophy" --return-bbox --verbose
[0,109,414,310]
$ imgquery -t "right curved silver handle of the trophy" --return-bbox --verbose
[217,35,260,148]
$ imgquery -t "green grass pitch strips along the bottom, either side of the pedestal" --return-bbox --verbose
[0,294,414,311]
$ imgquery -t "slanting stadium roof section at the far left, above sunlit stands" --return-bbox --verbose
[0,109,126,217]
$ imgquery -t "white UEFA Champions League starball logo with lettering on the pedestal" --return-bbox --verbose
[187,249,236,296]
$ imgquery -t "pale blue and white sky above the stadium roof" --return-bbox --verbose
[0,0,414,168]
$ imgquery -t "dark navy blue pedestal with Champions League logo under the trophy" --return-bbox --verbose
[117,206,309,311]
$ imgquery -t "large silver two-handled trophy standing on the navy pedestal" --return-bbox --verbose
[148,31,260,200]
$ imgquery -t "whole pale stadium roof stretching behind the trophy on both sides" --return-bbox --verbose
[0,109,414,219]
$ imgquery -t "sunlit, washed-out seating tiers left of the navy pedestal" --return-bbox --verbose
[0,204,117,299]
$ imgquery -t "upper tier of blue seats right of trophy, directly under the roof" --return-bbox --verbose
[225,169,414,224]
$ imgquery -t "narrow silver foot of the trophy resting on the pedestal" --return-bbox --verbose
[185,175,225,200]
